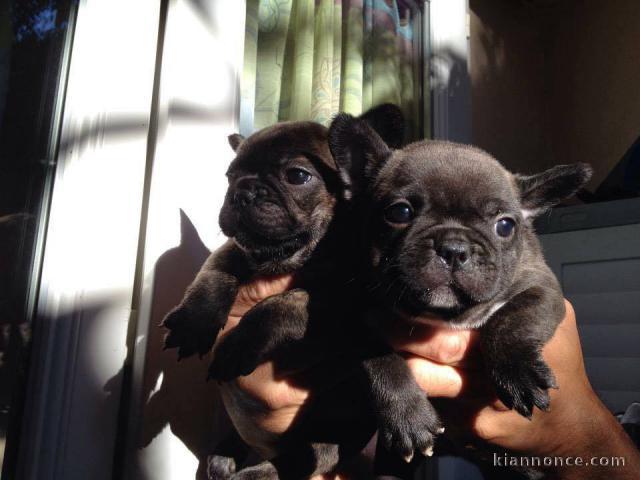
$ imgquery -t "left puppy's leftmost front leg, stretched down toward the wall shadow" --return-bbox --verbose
[162,242,248,359]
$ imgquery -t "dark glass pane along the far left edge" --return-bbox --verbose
[0,0,74,472]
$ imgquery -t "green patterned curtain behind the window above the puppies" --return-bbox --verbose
[240,0,422,138]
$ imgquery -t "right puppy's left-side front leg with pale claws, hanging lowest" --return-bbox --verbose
[363,352,442,462]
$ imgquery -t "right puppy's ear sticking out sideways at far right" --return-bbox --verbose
[515,163,593,218]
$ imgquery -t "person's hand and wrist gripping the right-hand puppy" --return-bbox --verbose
[389,302,640,478]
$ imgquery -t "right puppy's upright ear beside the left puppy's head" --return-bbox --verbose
[329,113,391,200]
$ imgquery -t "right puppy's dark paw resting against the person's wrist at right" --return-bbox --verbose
[489,352,557,419]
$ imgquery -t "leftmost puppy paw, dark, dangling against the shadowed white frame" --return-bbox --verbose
[160,306,220,360]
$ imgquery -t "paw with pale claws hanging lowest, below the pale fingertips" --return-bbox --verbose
[378,392,444,462]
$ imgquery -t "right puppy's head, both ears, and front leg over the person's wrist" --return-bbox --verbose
[329,114,591,424]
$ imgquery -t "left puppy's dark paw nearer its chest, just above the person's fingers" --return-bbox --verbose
[208,325,267,382]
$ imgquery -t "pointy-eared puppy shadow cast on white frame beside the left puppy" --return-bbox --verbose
[114,211,233,480]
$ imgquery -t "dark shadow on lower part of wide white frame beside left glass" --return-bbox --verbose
[14,292,136,479]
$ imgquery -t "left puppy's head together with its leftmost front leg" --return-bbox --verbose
[163,122,340,358]
